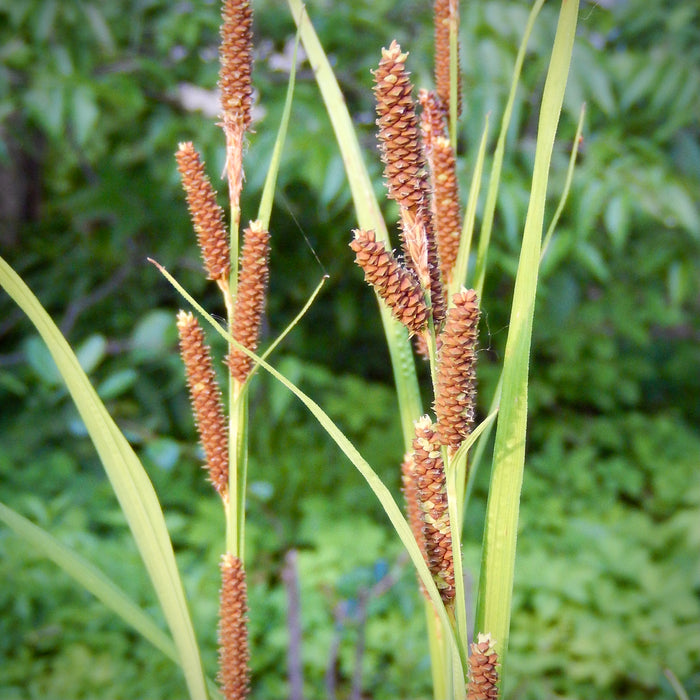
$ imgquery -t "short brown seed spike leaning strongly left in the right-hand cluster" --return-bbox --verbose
[350,229,428,333]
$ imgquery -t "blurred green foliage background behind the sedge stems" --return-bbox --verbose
[0,0,700,700]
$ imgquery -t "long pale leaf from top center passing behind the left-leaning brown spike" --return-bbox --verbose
[287,0,423,450]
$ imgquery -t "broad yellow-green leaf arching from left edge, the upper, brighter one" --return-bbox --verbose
[0,258,207,700]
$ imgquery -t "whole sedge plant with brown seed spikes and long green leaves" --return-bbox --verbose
[0,0,578,700]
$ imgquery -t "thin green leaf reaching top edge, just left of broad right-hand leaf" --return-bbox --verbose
[473,0,544,299]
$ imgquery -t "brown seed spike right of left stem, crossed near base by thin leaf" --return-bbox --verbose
[231,221,270,382]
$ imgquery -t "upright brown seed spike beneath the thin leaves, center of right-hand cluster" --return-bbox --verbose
[435,289,479,452]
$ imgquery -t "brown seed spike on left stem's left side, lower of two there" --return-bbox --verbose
[177,311,228,498]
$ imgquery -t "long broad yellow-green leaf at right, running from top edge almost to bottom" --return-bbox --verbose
[477,0,578,677]
